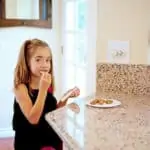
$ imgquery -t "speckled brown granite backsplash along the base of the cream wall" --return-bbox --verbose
[96,63,150,95]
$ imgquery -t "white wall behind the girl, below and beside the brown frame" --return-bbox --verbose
[0,0,61,137]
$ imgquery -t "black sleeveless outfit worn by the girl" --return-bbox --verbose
[13,87,61,150]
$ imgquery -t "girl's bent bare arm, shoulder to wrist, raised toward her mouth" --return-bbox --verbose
[15,84,47,124]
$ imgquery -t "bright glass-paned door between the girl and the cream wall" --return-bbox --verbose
[62,0,87,96]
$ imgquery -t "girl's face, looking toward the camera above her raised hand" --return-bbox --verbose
[29,47,52,77]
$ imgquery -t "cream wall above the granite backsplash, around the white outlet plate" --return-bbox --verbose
[97,0,150,64]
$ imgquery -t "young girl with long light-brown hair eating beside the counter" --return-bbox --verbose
[13,39,80,150]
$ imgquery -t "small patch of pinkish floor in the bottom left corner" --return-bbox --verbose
[0,138,13,150]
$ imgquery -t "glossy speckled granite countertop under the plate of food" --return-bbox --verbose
[46,93,150,150]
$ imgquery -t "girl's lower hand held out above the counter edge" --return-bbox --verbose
[66,87,80,98]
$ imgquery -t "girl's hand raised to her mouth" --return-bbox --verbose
[39,72,52,91]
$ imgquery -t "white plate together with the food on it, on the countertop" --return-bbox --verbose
[87,98,121,108]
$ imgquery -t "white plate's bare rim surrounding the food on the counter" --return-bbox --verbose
[87,99,121,108]
